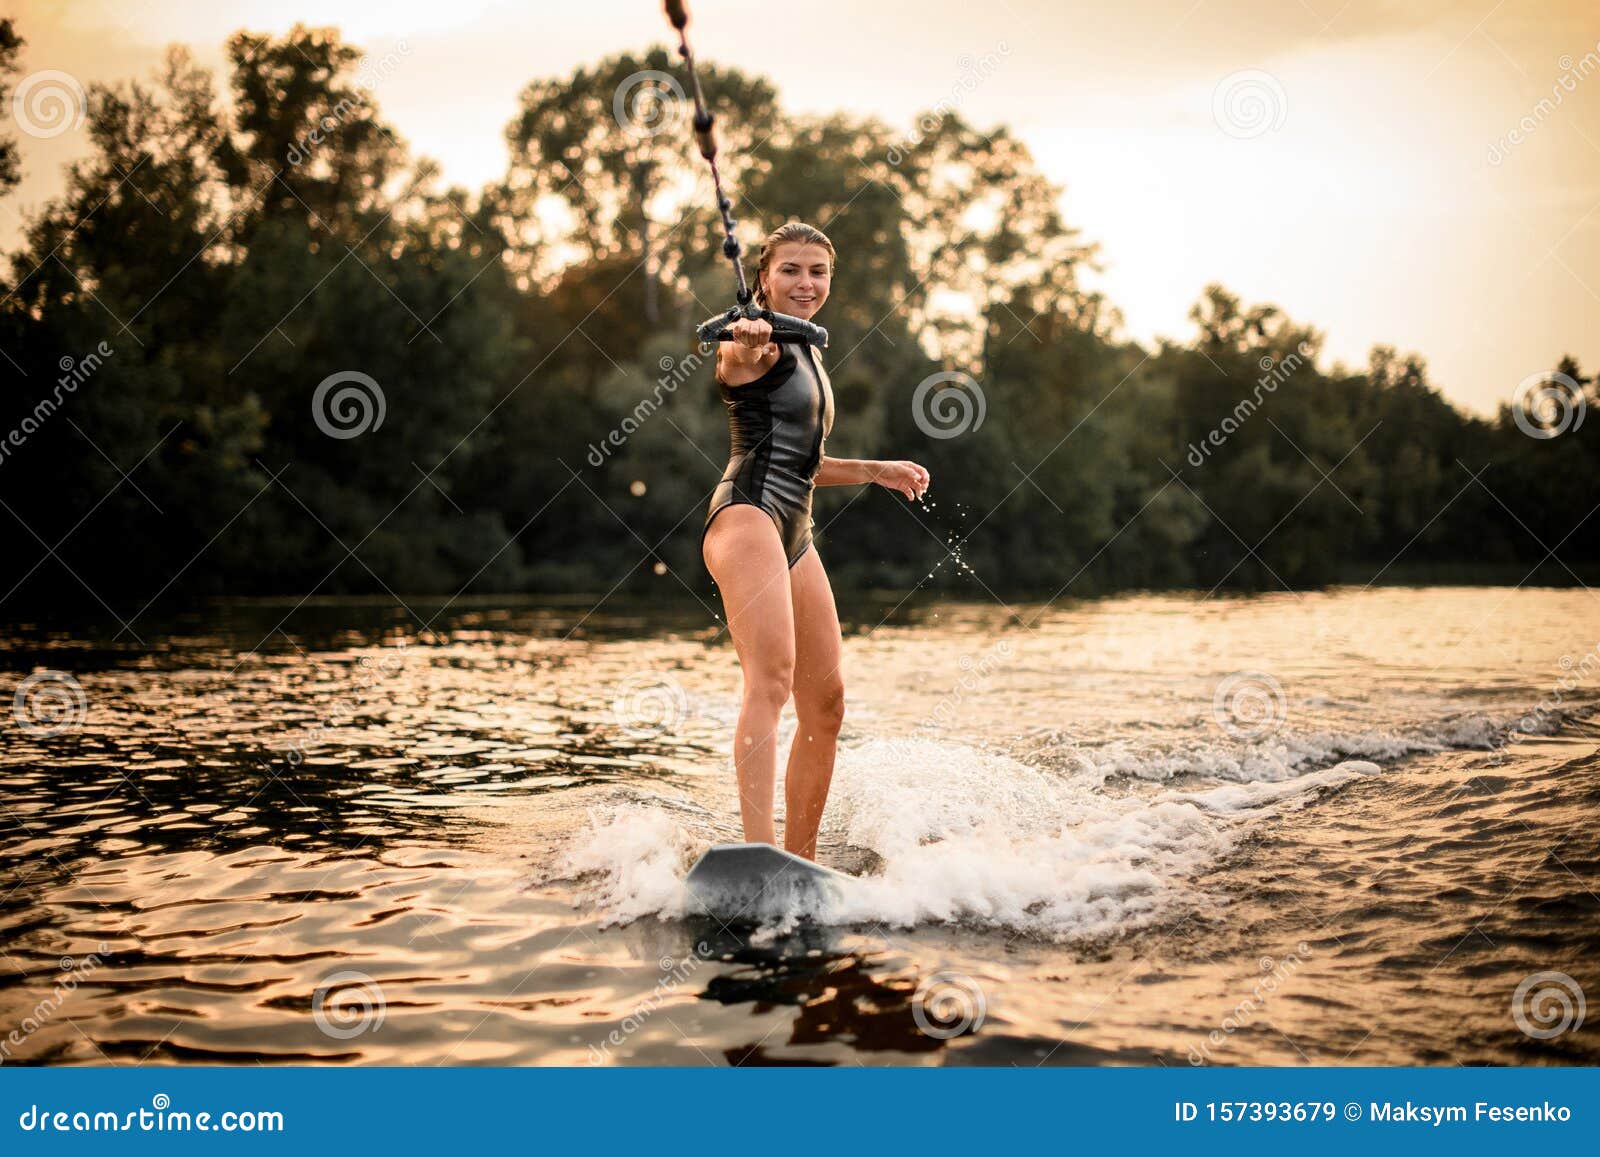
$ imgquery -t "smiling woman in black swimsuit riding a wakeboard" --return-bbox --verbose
[701,221,928,859]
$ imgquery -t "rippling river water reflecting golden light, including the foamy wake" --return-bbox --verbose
[0,587,1600,1064]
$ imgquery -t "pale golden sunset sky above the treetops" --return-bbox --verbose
[0,0,1600,413]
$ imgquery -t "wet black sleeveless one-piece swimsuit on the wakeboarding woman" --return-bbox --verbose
[701,342,834,566]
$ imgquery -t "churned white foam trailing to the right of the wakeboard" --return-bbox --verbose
[812,741,1324,939]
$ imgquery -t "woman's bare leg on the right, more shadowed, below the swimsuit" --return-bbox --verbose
[784,546,845,859]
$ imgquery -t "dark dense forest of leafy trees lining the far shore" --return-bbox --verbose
[0,22,1600,616]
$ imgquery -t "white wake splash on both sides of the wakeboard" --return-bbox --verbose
[562,739,1378,941]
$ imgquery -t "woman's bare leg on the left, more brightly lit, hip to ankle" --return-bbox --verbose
[702,502,795,843]
